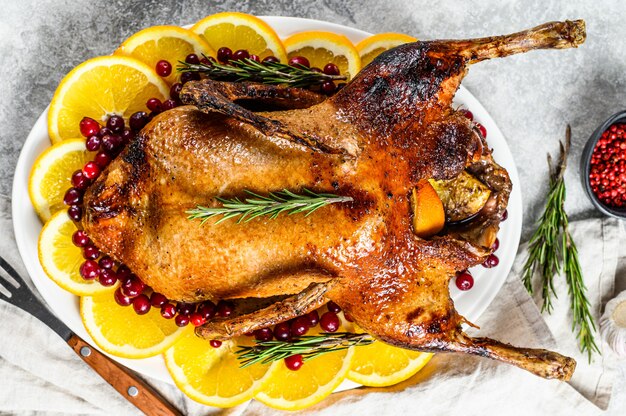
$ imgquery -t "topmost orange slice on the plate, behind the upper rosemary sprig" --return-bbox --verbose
[191,12,287,63]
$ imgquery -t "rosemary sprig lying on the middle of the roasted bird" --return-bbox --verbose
[186,188,353,224]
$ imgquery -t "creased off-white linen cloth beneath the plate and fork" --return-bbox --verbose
[0,190,626,415]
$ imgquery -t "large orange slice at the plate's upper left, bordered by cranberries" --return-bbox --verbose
[48,56,169,143]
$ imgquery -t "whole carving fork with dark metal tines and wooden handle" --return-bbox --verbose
[0,257,182,416]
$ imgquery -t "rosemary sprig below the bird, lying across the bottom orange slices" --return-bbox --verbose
[235,332,374,368]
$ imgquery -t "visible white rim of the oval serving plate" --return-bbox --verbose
[12,16,522,390]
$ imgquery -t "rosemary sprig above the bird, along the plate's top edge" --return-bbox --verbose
[176,55,347,88]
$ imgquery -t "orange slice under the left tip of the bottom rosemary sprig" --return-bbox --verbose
[163,328,270,407]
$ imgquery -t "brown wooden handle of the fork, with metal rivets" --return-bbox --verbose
[67,334,182,416]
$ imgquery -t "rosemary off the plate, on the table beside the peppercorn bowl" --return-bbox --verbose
[522,126,599,361]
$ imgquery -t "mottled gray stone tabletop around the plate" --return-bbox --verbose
[0,0,626,414]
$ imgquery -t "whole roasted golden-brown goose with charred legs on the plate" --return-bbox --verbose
[83,21,585,380]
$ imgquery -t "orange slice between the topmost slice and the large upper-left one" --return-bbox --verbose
[114,26,215,84]
